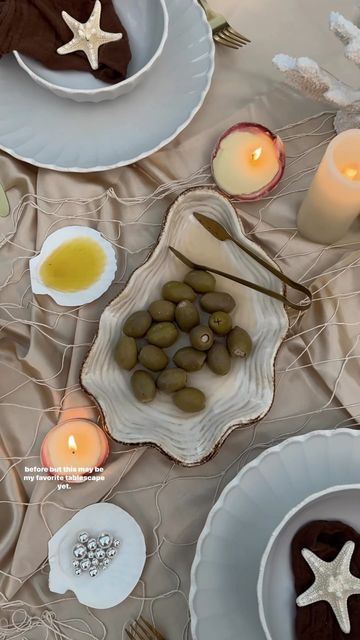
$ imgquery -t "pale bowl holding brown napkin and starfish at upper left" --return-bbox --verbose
[14,0,169,102]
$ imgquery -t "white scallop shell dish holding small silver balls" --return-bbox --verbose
[49,502,146,609]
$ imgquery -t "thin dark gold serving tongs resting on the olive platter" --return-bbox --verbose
[170,213,312,311]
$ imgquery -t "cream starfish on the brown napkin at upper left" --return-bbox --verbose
[57,0,123,70]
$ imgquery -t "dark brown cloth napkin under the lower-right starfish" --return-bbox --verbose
[291,520,360,640]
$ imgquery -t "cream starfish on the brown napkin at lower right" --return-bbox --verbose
[296,542,360,633]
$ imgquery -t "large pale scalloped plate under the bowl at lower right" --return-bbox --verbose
[190,429,360,640]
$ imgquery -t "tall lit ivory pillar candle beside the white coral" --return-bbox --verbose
[297,129,360,244]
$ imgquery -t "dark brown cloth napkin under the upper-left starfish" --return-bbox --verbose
[0,0,131,84]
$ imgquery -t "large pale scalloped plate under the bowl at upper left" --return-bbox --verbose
[0,0,214,172]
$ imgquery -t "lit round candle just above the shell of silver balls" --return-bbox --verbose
[40,418,109,483]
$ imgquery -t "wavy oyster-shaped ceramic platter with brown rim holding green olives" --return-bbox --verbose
[81,188,288,466]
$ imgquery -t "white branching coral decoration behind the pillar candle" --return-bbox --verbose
[273,11,360,133]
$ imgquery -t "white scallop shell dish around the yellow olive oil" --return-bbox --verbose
[29,226,117,307]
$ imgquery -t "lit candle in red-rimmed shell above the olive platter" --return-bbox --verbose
[212,122,285,200]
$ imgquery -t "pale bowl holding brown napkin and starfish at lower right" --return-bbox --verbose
[257,484,360,640]
